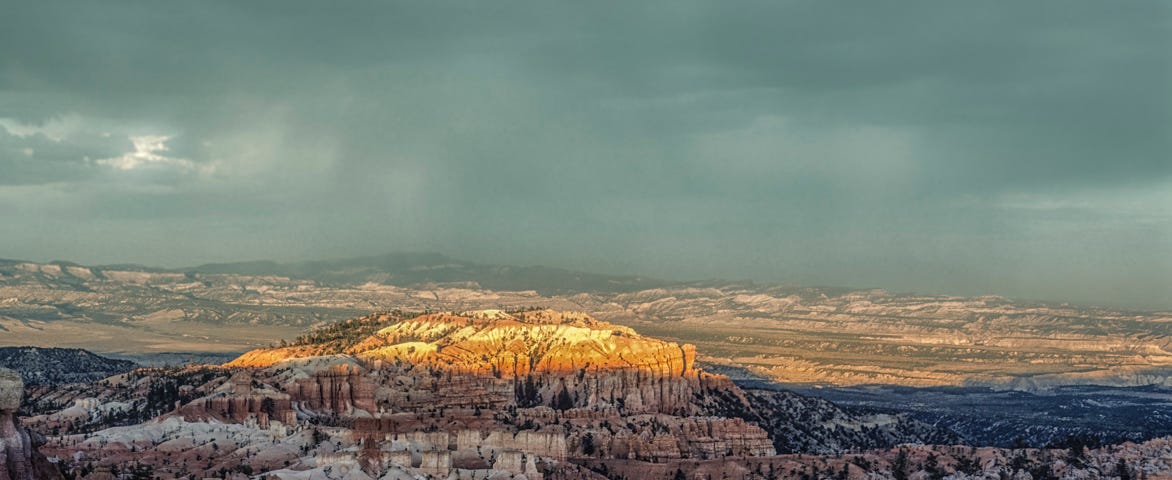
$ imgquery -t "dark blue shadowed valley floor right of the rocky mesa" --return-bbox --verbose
[704,365,1172,447]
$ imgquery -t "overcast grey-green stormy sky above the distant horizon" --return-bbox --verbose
[0,0,1172,308]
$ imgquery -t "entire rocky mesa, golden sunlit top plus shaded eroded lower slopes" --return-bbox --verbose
[18,310,998,479]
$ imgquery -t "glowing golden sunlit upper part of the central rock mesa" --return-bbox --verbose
[229,310,699,378]
